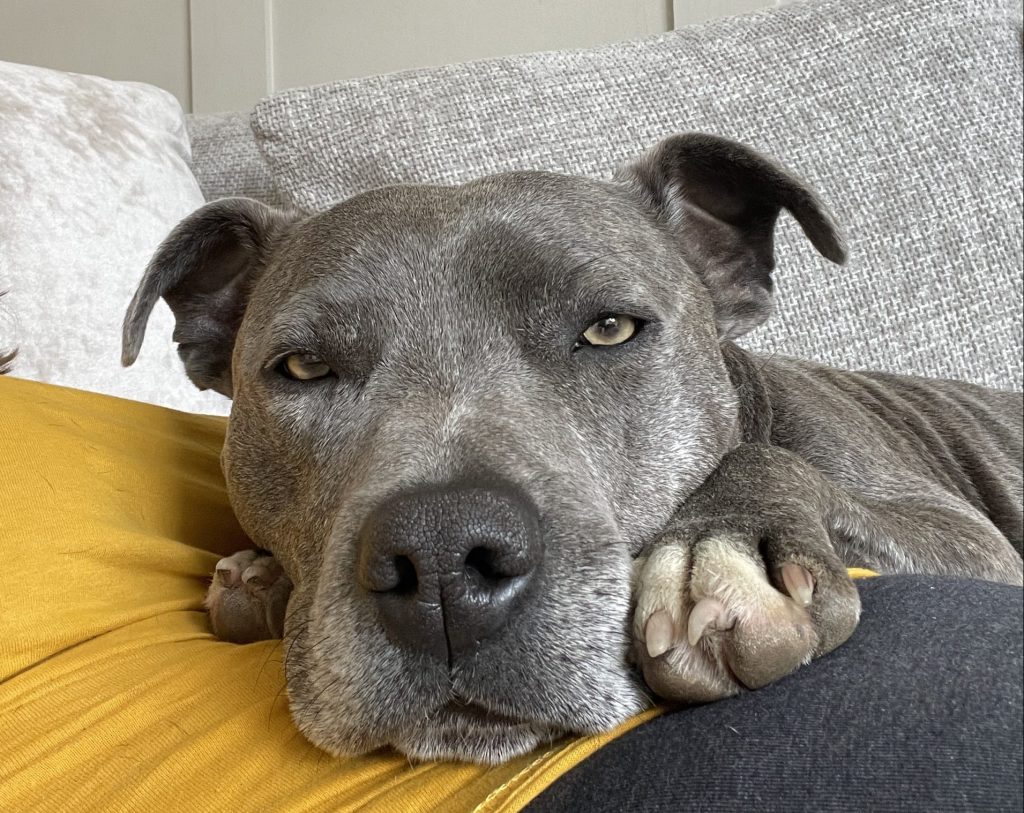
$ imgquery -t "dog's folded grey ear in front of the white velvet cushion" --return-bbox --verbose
[121,198,298,397]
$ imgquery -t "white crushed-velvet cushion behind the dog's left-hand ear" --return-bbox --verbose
[0,62,229,414]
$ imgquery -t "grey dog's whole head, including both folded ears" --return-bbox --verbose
[125,135,844,762]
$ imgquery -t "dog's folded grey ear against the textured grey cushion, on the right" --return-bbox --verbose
[615,133,846,340]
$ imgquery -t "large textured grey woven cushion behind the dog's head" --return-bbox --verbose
[252,0,1024,389]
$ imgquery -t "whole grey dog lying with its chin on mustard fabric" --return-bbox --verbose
[124,134,1024,763]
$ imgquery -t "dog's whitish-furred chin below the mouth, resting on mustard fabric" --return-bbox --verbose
[391,702,568,765]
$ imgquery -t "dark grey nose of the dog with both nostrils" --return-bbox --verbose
[358,486,544,662]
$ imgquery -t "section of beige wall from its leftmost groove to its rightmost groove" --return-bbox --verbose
[190,0,673,111]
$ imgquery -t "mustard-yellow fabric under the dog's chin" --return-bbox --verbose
[0,378,880,813]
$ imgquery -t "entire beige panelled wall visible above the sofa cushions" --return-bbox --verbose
[0,0,782,113]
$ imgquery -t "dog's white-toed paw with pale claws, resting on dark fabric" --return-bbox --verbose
[633,532,860,702]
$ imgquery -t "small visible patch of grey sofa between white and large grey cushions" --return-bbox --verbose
[187,113,286,205]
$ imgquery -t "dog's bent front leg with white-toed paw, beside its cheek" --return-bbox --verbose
[633,444,1024,701]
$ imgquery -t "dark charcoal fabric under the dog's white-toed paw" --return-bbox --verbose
[526,576,1024,813]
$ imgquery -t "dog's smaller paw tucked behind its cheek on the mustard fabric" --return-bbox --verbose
[206,551,292,644]
